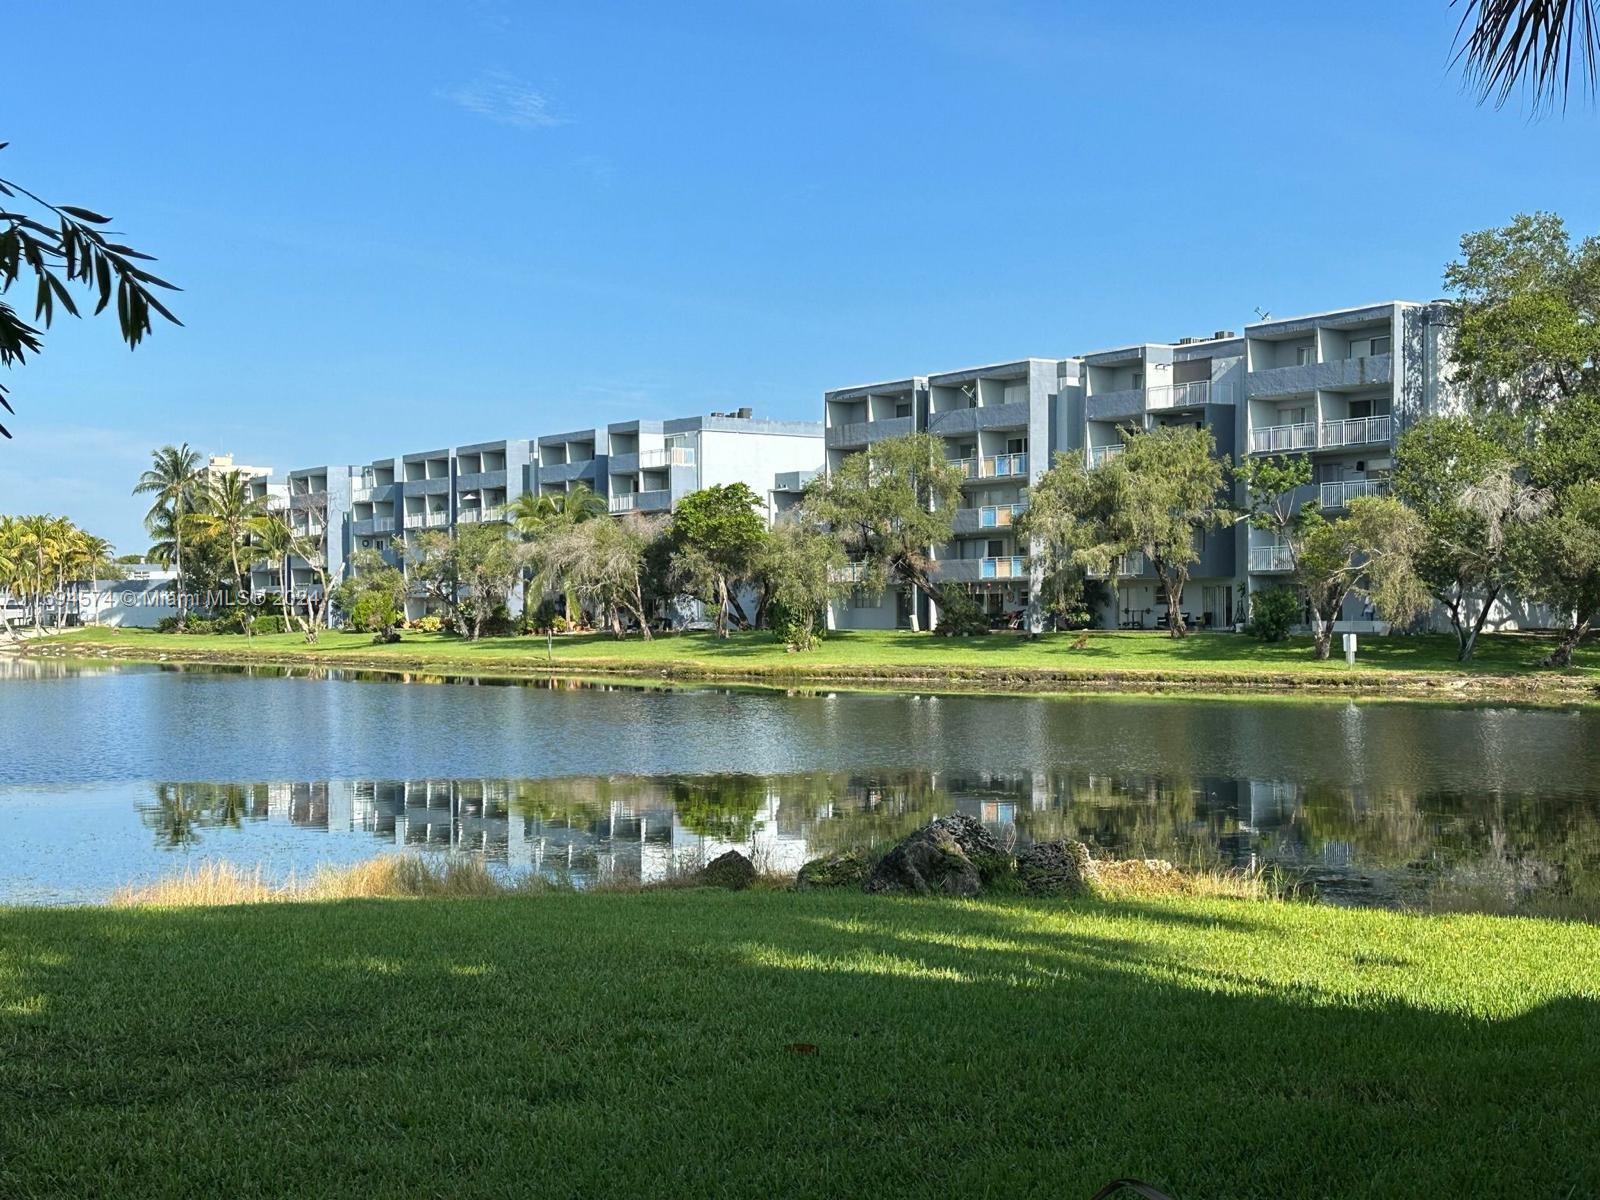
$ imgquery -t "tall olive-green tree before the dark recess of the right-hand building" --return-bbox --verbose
[1120,426,1232,638]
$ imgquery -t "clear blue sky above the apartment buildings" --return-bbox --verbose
[0,0,1600,550]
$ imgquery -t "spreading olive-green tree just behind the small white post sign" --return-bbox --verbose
[1294,496,1429,659]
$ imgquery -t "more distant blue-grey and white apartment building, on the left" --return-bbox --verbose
[251,408,822,616]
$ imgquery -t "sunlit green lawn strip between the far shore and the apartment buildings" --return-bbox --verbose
[21,629,1600,691]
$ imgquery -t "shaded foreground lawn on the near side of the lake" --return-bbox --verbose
[0,890,1600,1200]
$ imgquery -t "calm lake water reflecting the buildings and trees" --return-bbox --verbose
[0,659,1600,902]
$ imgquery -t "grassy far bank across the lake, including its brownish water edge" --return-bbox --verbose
[26,629,1600,698]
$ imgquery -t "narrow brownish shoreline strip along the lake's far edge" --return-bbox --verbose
[28,635,1600,706]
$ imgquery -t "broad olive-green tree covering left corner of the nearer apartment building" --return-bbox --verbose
[802,434,962,640]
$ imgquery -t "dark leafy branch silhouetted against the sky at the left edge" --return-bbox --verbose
[0,142,182,438]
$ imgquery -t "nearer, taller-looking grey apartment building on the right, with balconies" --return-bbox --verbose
[824,301,1451,640]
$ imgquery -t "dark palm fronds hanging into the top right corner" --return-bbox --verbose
[1451,0,1600,106]
